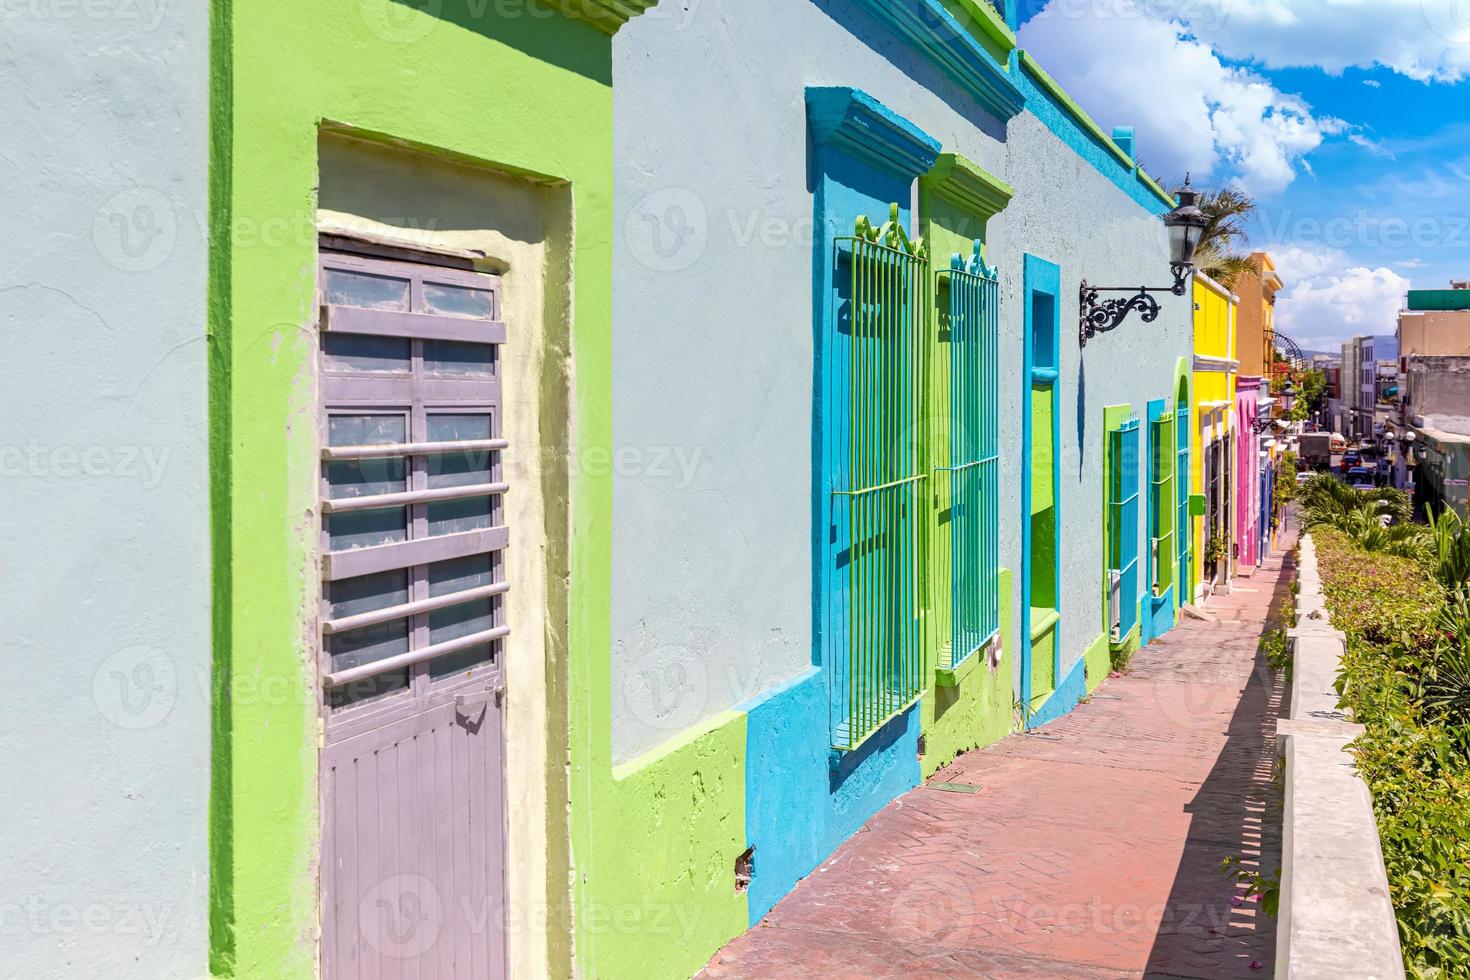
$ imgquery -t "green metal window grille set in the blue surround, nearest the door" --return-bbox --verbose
[829,204,931,749]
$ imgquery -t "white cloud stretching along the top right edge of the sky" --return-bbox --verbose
[1147,0,1470,82]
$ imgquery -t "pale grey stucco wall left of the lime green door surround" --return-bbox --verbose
[0,0,210,979]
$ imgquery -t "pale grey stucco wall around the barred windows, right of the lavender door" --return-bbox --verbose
[612,0,1188,760]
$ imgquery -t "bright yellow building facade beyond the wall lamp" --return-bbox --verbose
[1180,272,1241,602]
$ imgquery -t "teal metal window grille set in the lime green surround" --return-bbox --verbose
[935,242,1000,670]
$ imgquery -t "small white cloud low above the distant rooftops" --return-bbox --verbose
[1272,245,1410,351]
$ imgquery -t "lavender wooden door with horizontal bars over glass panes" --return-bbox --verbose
[319,251,510,980]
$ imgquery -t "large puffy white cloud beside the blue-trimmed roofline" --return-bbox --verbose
[1020,0,1347,195]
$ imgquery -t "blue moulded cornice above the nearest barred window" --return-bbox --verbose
[807,87,939,178]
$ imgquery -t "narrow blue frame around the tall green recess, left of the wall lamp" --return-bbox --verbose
[1020,253,1061,705]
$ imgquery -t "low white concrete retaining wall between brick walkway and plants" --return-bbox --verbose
[1276,535,1404,979]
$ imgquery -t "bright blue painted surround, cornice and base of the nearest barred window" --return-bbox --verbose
[745,88,939,923]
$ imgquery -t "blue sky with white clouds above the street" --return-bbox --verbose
[1020,0,1470,348]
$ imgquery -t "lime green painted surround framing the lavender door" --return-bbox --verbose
[209,0,623,980]
